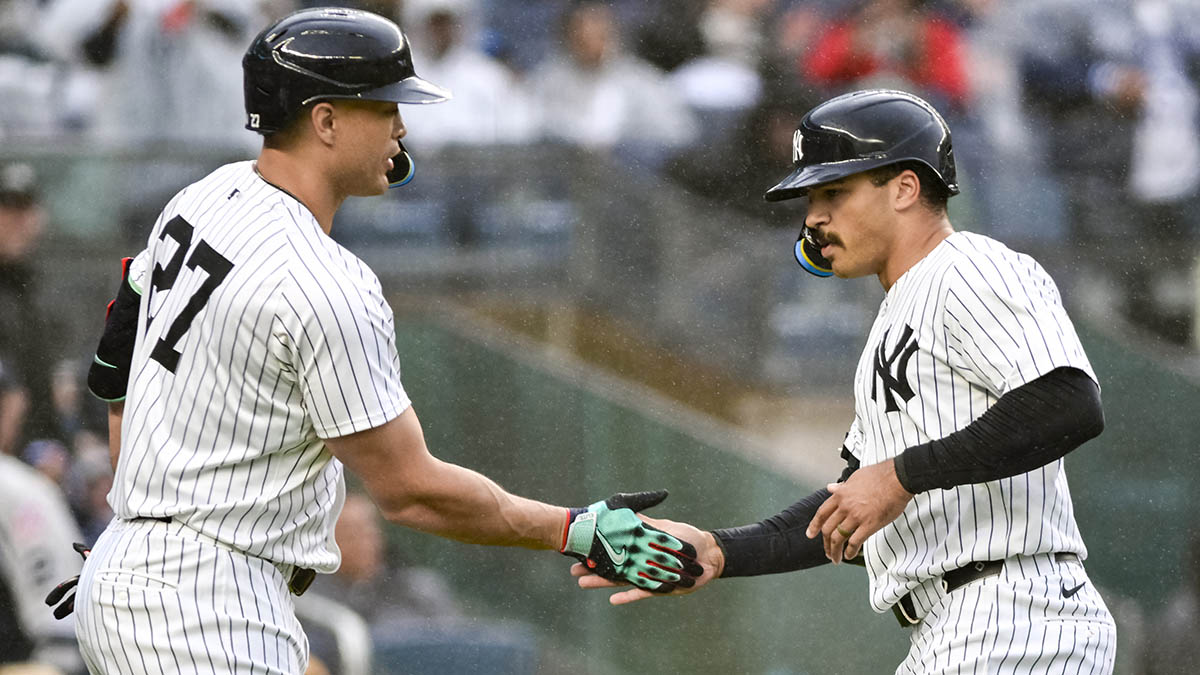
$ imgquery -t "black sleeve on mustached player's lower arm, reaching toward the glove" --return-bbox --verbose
[713,448,858,579]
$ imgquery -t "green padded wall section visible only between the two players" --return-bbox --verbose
[391,322,907,675]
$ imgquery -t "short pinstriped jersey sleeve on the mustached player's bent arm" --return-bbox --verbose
[944,251,1096,396]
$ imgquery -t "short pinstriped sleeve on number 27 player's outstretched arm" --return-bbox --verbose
[281,270,410,438]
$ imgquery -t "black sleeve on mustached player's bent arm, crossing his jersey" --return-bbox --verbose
[895,368,1104,494]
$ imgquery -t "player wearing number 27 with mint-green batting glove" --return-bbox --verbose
[48,8,701,674]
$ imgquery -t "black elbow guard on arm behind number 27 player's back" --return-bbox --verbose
[88,251,149,402]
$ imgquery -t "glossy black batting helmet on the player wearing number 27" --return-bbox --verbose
[241,7,450,135]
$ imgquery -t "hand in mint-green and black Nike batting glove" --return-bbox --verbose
[562,490,703,593]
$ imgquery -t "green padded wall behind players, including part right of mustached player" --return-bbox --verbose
[379,321,1185,675]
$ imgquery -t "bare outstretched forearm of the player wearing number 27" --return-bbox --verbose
[379,458,566,550]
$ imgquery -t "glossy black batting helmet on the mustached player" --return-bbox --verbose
[764,89,959,202]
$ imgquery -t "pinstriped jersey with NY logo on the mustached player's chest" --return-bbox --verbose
[846,232,1096,611]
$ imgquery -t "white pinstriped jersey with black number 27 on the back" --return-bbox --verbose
[109,161,409,572]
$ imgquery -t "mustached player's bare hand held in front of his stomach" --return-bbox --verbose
[806,460,912,563]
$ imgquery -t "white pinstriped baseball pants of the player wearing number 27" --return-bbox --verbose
[76,519,308,675]
